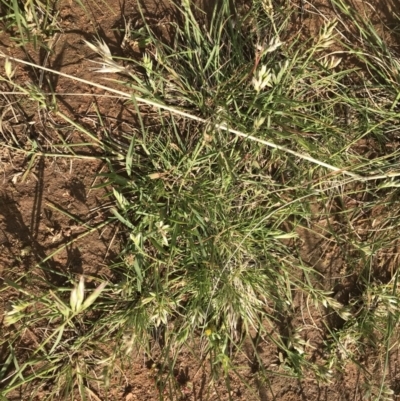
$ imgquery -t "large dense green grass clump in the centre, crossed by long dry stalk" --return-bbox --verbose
[89,3,400,380]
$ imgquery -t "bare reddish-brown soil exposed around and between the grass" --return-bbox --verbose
[0,0,400,401]
